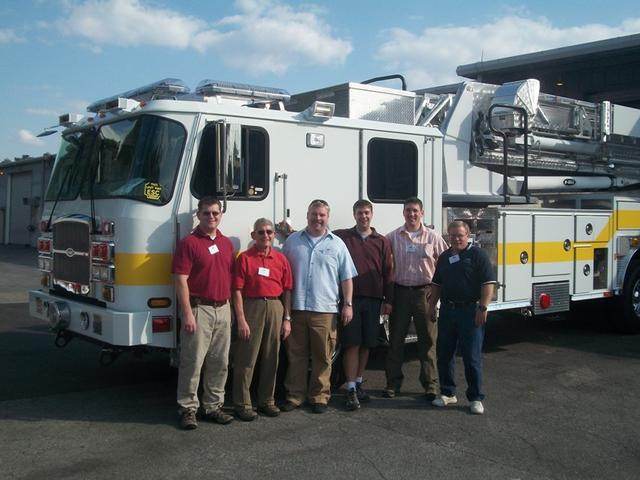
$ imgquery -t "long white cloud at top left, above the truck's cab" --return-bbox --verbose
[57,0,352,73]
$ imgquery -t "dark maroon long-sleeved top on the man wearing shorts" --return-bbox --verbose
[333,227,393,303]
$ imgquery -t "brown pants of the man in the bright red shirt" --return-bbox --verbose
[233,298,284,409]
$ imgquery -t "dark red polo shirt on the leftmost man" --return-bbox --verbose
[171,227,233,302]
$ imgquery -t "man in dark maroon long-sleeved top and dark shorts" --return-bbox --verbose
[333,200,393,410]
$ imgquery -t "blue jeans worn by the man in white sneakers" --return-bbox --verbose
[436,304,484,402]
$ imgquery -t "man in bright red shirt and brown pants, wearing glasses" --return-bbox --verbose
[232,218,293,422]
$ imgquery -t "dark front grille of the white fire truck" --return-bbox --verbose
[53,220,91,285]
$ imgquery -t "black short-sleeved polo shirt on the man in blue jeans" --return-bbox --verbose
[433,245,496,302]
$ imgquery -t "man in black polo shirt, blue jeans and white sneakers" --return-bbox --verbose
[427,220,496,415]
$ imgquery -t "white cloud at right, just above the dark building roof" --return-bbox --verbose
[376,13,640,89]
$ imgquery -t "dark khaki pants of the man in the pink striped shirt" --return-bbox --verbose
[386,285,440,395]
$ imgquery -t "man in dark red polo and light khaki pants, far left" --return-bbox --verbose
[172,197,233,430]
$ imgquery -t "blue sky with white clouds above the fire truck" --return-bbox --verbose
[0,0,640,161]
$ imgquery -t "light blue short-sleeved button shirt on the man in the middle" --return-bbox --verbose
[283,230,358,313]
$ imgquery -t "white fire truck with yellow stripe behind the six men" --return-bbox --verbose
[30,80,640,349]
